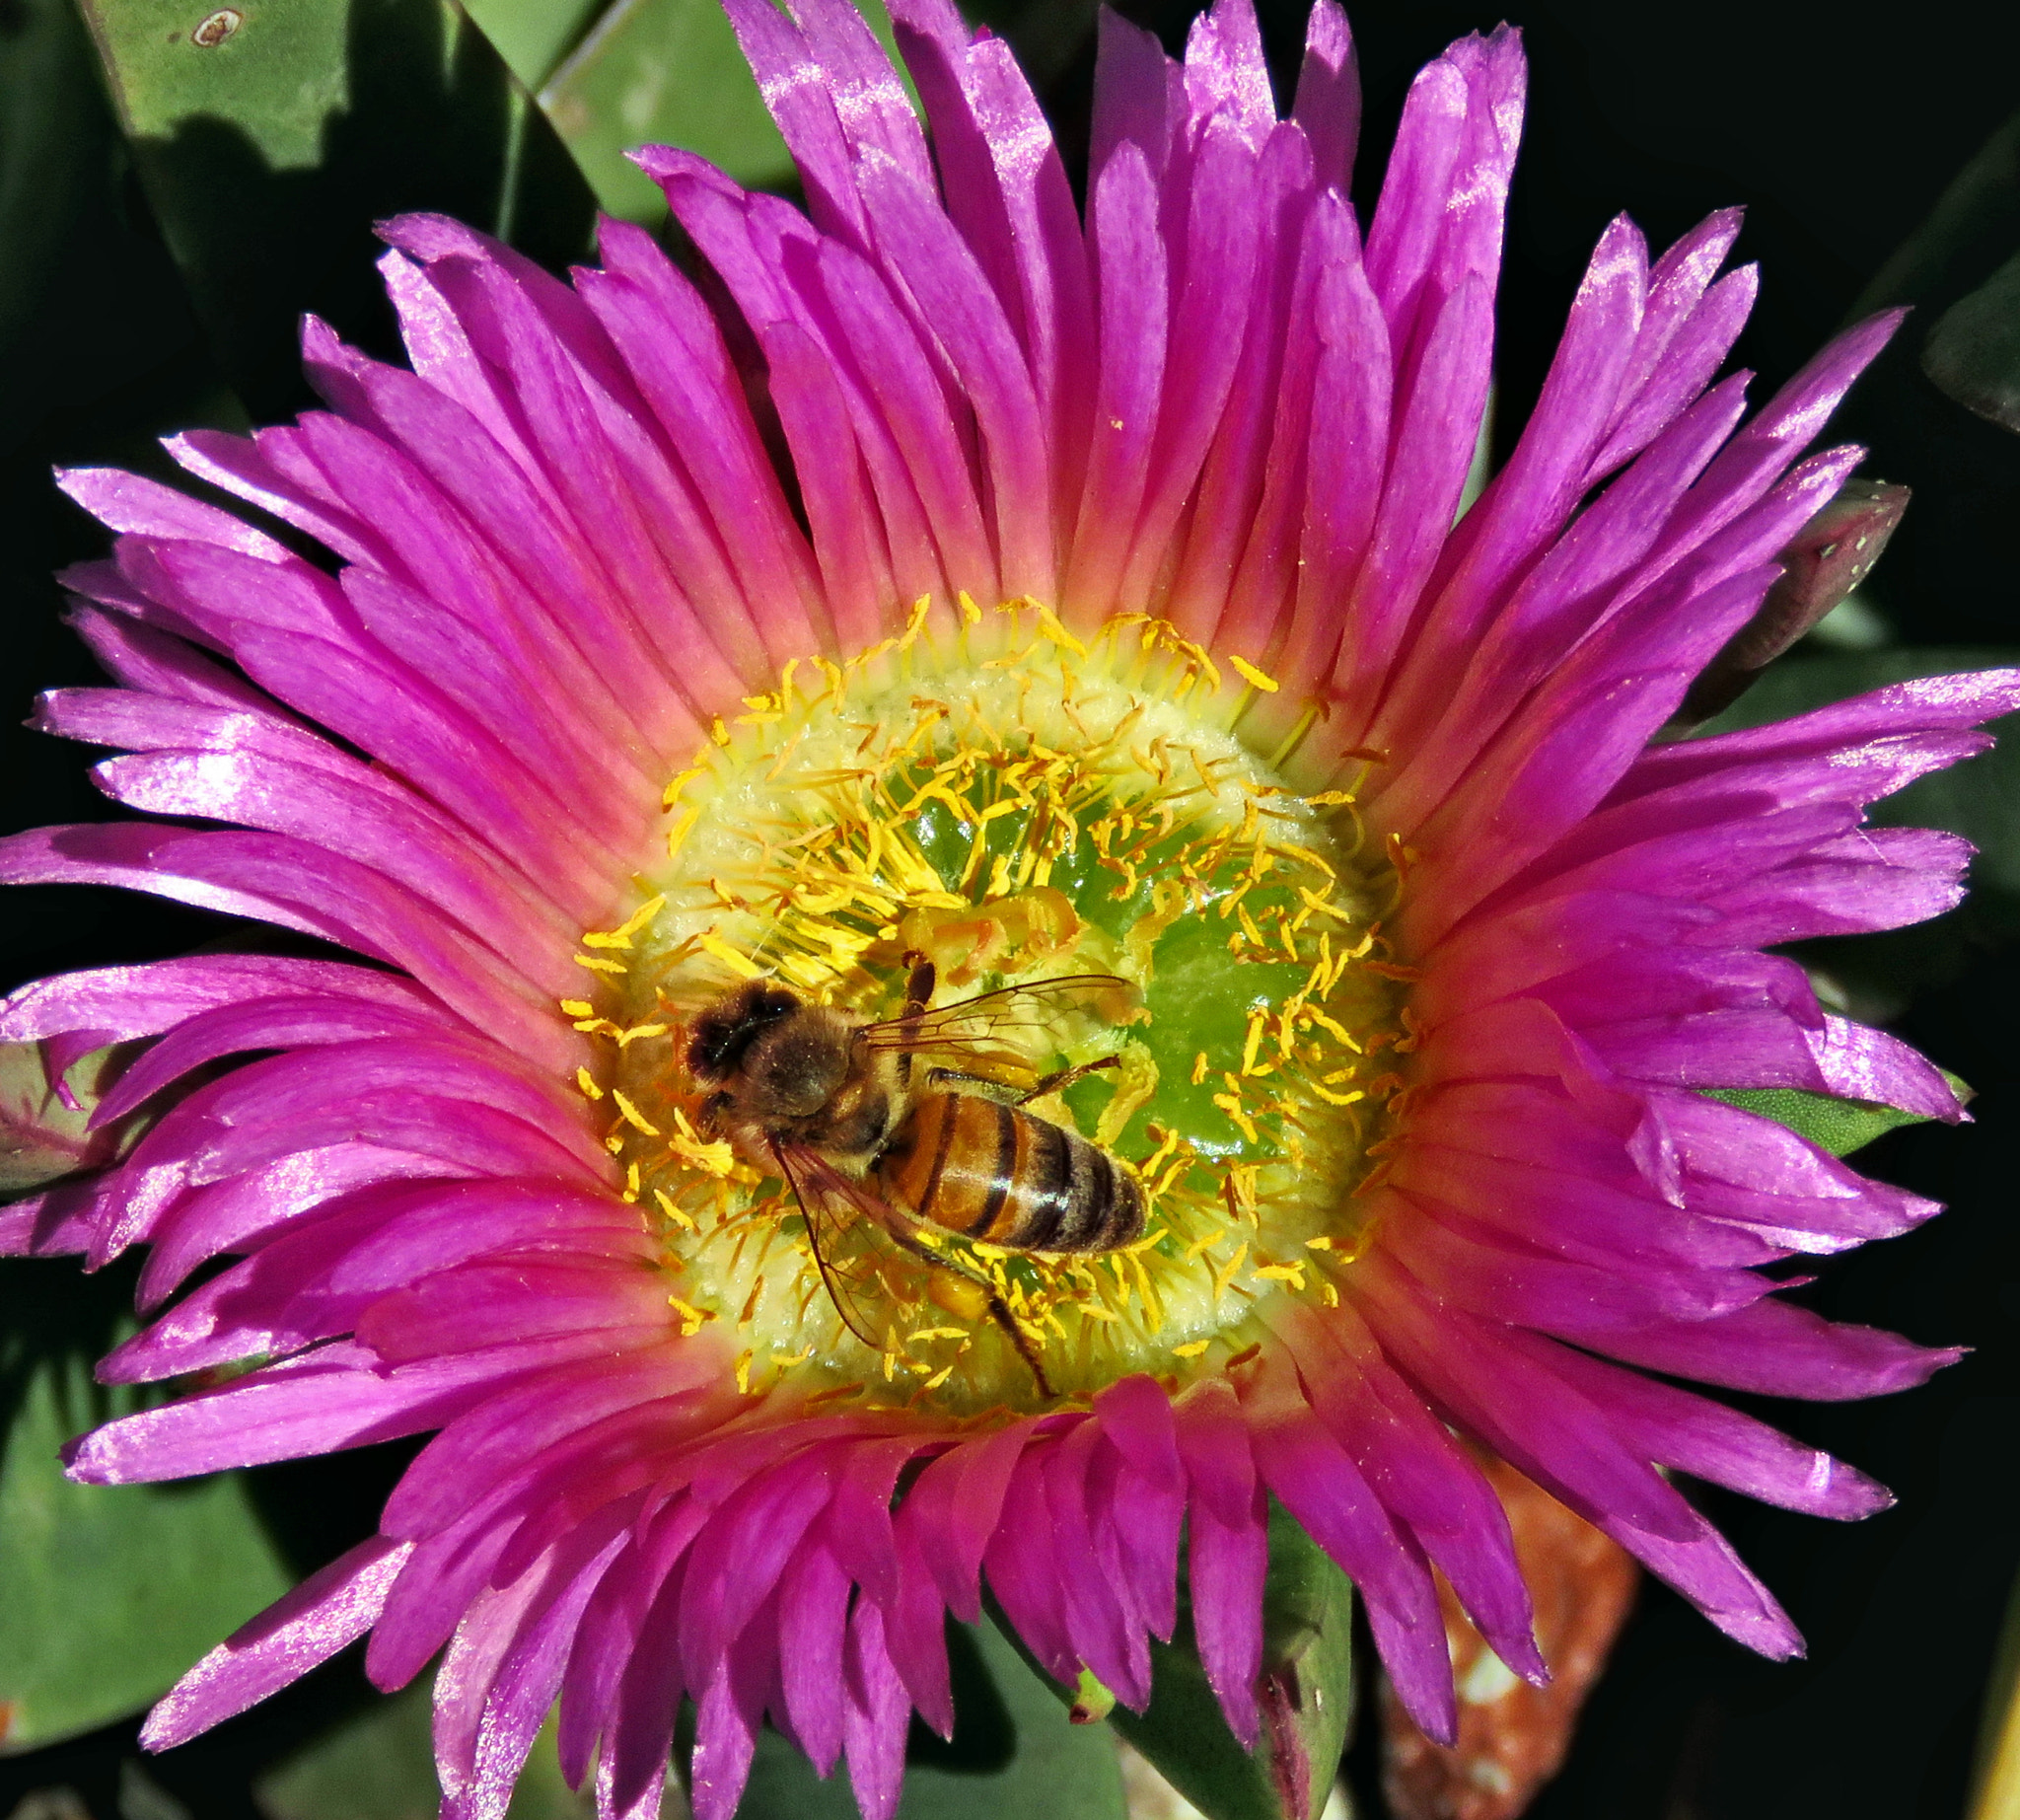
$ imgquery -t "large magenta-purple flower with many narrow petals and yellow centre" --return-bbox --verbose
[0,0,2020,1820]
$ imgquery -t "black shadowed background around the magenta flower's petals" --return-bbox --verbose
[0,0,2020,1820]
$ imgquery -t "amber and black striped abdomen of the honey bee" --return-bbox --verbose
[875,1093,1143,1251]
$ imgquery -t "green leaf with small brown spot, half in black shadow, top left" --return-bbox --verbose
[79,0,594,416]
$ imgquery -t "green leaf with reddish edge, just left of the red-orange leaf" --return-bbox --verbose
[998,1500,1353,1820]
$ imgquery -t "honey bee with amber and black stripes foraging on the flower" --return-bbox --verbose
[686,954,1143,1398]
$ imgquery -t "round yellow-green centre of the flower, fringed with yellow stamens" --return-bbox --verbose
[563,598,1410,1416]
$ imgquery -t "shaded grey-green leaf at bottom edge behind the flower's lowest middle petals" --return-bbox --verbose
[738,1624,1125,1820]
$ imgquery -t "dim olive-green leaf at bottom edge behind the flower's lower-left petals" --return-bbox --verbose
[252,1679,596,1820]
